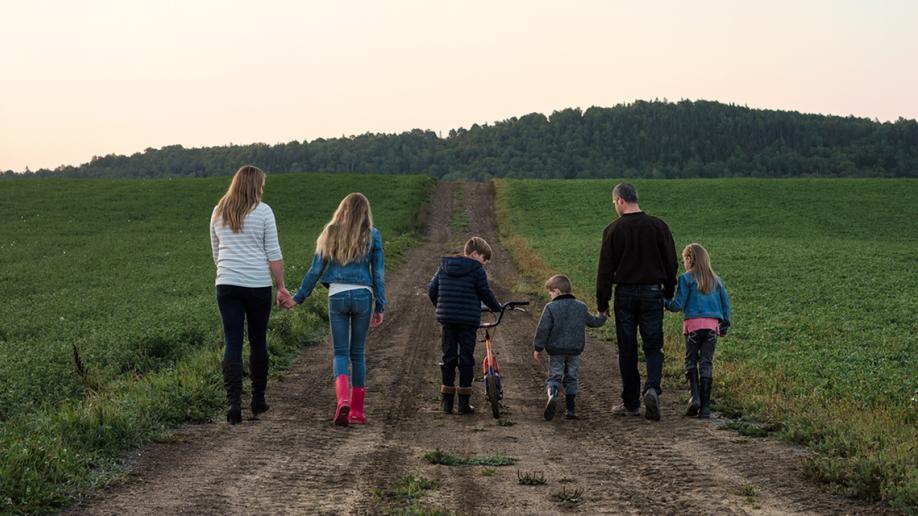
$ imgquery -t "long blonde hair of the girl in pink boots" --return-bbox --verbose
[316,192,373,265]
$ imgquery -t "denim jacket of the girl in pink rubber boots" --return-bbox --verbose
[293,228,388,313]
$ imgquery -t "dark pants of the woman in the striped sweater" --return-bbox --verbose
[217,285,273,364]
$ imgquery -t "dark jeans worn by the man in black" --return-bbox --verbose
[615,285,663,410]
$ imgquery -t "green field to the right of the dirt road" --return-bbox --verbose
[497,179,918,512]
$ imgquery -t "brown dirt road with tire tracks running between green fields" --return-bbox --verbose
[73,183,886,514]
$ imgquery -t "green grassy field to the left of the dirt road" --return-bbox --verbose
[0,174,432,513]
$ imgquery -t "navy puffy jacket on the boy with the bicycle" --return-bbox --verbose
[427,256,501,326]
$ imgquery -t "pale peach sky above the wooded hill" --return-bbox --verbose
[0,0,918,171]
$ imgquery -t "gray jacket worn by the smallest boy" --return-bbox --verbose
[532,294,606,355]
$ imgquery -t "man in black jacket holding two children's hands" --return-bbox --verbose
[596,183,678,421]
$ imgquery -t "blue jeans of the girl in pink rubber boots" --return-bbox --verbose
[328,288,373,387]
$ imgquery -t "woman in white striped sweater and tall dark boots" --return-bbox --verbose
[210,165,290,424]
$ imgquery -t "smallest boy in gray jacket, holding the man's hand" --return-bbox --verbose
[532,274,606,421]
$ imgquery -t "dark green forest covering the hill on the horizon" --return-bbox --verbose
[2,100,918,180]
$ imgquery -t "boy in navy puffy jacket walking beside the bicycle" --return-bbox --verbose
[427,237,501,414]
